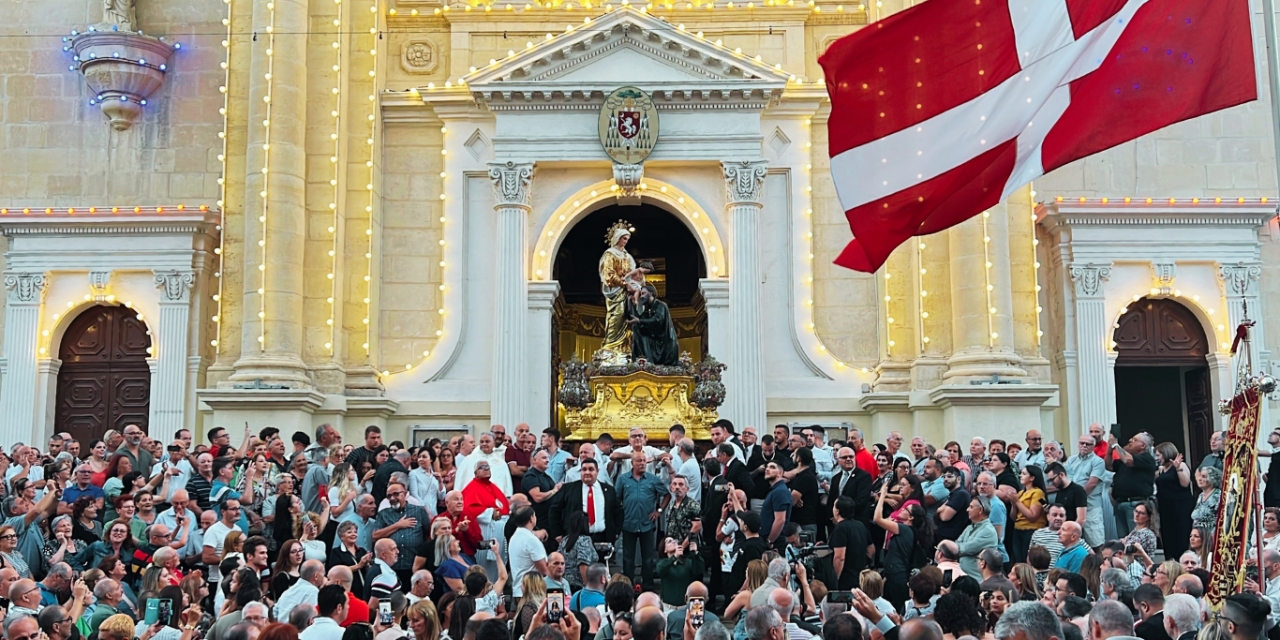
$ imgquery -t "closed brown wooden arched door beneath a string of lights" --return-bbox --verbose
[54,306,151,444]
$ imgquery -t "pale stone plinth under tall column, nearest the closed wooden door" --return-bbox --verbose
[196,389,325,434]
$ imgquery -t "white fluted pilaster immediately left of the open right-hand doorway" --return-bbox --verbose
[1068,262,1115,429]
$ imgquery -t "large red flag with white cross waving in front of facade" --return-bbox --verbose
[819,0,1257,271]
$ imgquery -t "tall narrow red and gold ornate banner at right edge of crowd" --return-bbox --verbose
[1204,384,1262,611]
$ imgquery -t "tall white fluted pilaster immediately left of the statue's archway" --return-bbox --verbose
[489,161,534,425]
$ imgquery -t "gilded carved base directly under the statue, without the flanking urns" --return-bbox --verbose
[559,371,718,442]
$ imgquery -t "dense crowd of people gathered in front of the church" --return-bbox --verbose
[0,420,1280,640]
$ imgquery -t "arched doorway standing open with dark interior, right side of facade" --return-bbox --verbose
[1112,298,1213,468]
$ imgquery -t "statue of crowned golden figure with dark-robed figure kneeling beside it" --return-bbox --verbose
[598,220,680,366]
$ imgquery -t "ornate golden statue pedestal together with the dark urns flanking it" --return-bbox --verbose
[558,355,724,442]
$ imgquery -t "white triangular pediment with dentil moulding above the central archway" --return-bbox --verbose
[465,6,790,100]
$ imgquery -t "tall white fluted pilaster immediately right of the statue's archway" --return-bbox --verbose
[727,160,768,429]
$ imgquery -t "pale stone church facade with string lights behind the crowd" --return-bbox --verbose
[0,0,1280,451]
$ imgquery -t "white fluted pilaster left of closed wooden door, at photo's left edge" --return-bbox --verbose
[0,271,49,443]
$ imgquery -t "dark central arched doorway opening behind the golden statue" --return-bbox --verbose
[552,204,707,381]
